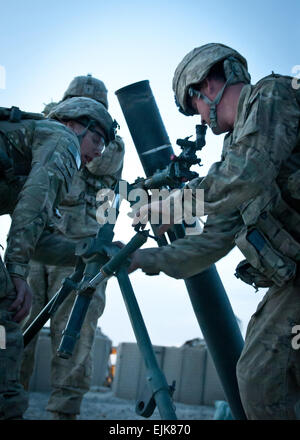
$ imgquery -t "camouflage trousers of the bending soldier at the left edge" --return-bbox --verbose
[0,257,28,420]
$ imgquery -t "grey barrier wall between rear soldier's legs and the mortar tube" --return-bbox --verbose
[112,343,225,405]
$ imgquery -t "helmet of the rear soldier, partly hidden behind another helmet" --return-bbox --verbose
[62,74,108,109]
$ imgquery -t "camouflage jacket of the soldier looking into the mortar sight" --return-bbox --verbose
[140,74,300,278]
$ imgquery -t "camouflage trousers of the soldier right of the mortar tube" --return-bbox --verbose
[237,276,300,420]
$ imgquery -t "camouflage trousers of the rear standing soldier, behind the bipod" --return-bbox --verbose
[21,262,105,414]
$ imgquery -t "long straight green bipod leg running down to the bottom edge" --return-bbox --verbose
[116,266,177,420]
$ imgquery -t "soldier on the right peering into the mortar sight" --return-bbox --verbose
[130,44,300,419]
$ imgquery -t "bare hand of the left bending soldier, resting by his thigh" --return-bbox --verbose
[9,277,32,322]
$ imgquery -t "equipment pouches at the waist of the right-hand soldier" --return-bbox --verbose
[235,193,300,287]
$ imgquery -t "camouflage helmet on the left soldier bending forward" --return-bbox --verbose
[49,97,118,144]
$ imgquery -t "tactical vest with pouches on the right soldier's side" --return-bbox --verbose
[233,75,300,288]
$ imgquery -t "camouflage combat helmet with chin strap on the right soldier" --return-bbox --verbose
[173,43,250,128]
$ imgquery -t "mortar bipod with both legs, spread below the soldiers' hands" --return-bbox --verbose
[57,231,177,420]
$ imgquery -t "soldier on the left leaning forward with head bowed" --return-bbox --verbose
[0,94,113,419]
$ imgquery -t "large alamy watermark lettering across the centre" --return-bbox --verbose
[96,181,204,225]
